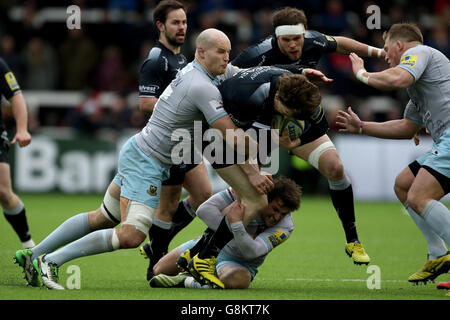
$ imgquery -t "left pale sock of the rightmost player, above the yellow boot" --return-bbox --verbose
[403,202,447,260]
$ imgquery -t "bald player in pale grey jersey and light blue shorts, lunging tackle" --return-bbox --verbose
[16,29,273,290]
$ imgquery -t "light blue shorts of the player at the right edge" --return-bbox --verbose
[417,129,450,178]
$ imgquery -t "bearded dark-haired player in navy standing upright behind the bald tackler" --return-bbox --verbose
[139,0,212,280]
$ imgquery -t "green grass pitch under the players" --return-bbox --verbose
[0,194,450,300]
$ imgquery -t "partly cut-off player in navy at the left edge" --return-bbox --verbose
[0,58,34,252]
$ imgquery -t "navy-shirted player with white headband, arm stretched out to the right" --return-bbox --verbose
[232,7,385,264]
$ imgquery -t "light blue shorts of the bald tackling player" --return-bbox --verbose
[113,137,169,209]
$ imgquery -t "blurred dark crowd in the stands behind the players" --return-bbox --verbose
[0,0,450,135]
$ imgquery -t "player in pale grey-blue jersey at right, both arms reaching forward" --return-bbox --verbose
[338,23,450,283]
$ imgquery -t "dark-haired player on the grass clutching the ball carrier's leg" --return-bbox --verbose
[150,177,301,289]
